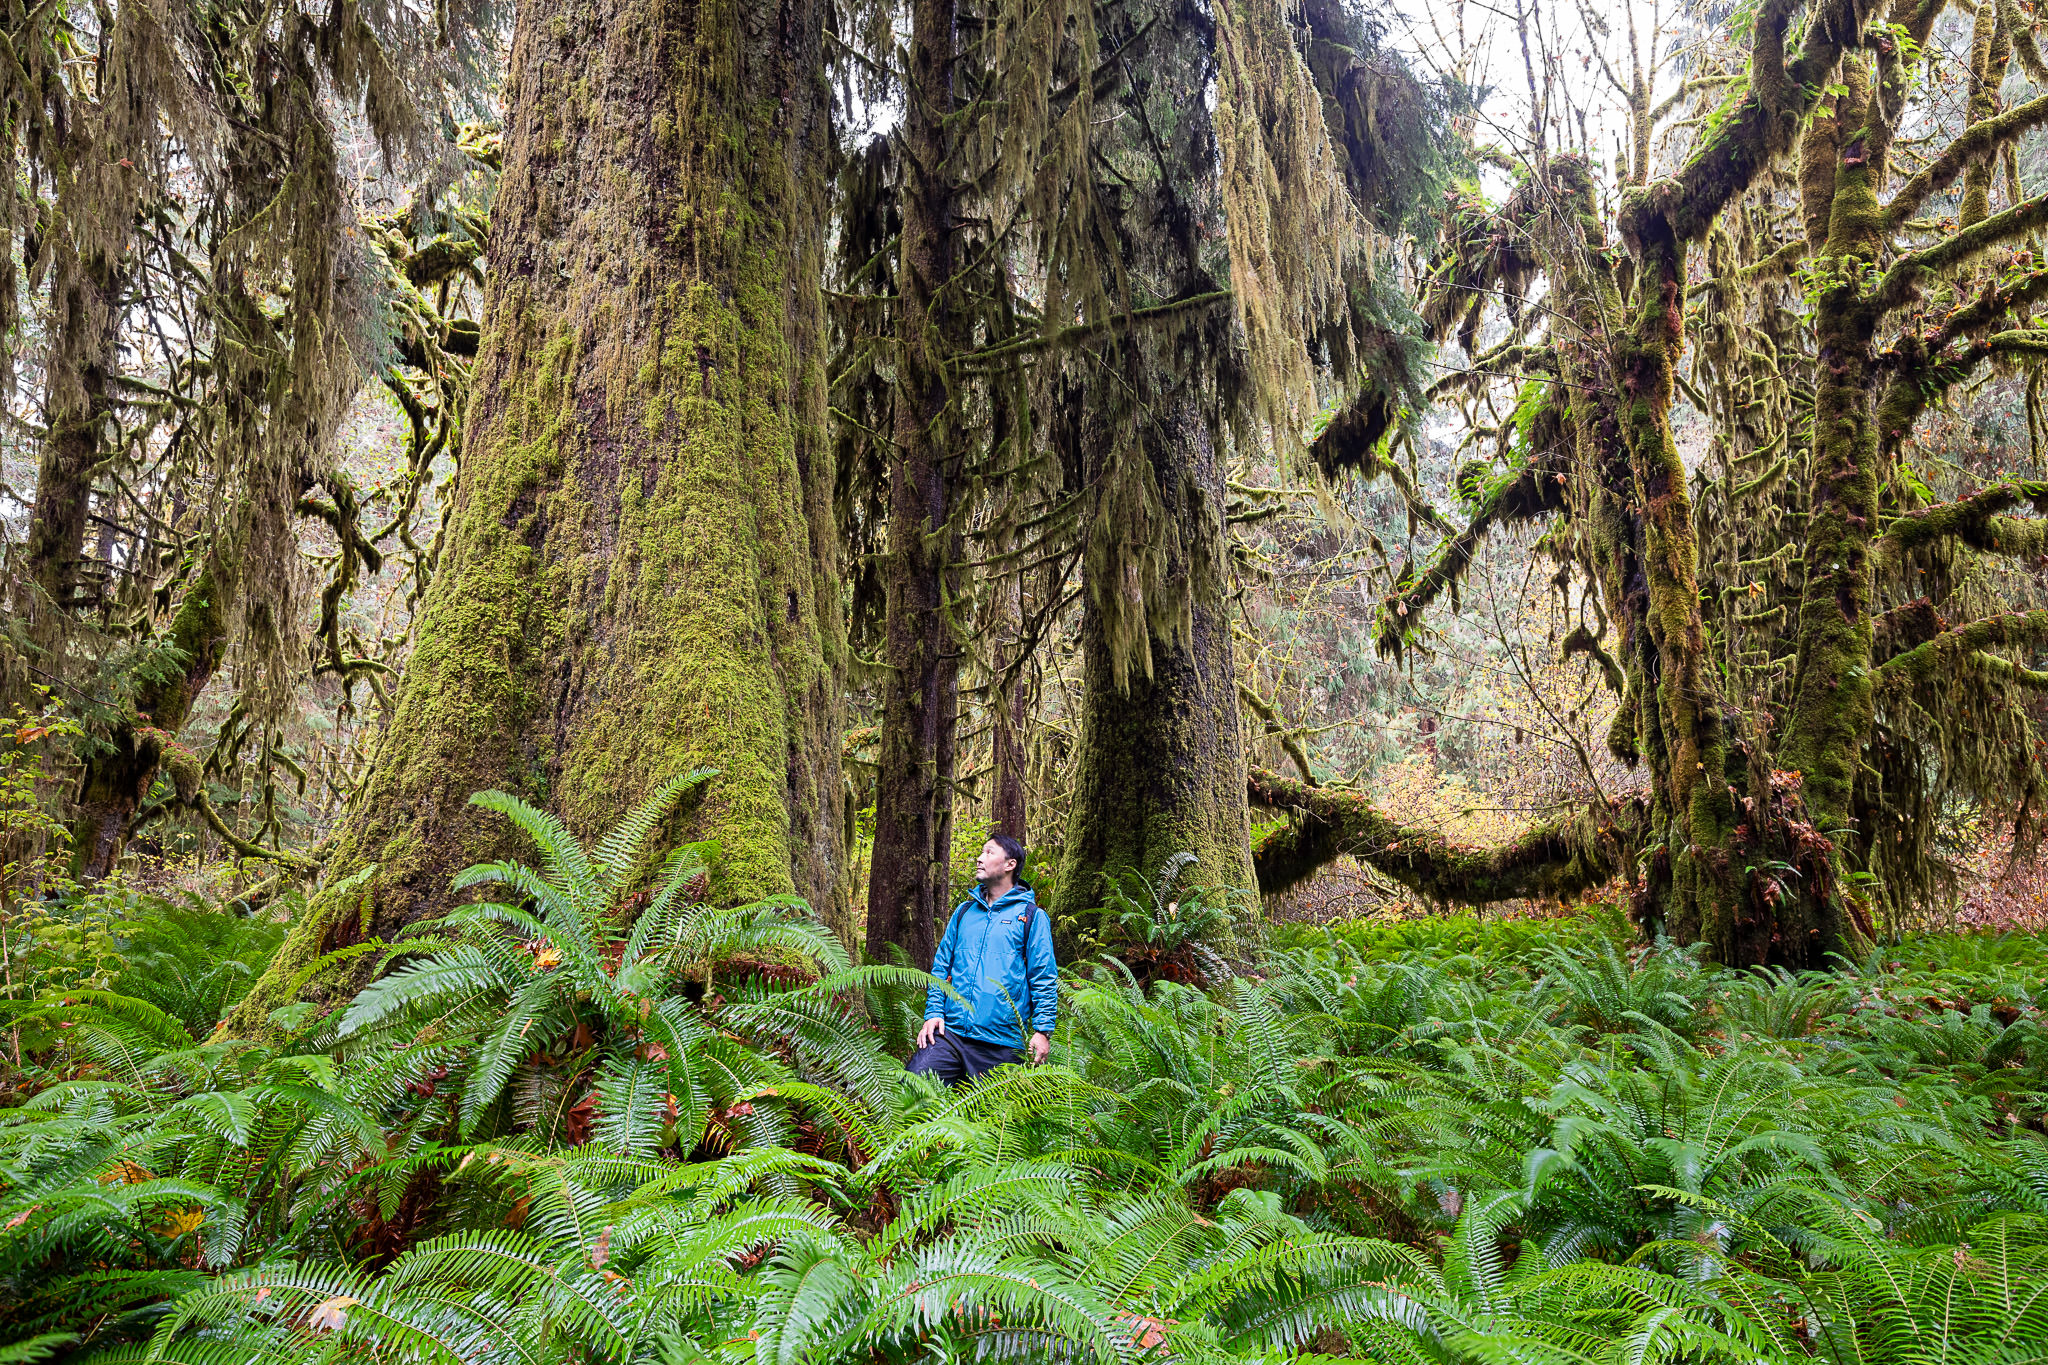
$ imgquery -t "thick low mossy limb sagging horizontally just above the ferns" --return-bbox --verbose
[1247,769,1645,905]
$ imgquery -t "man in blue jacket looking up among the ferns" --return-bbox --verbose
[909,835,1059,1085]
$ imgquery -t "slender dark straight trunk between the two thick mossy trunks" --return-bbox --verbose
[866,0,961,966]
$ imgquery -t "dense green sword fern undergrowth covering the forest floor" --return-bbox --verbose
[0,796,2048,1365]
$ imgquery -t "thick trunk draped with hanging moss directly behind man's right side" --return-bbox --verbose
[1057,0,1255,913]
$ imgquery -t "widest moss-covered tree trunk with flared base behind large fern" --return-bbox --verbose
[229,0,844,1029]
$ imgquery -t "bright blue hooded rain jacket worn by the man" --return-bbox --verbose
[924,886,1059,1048]
